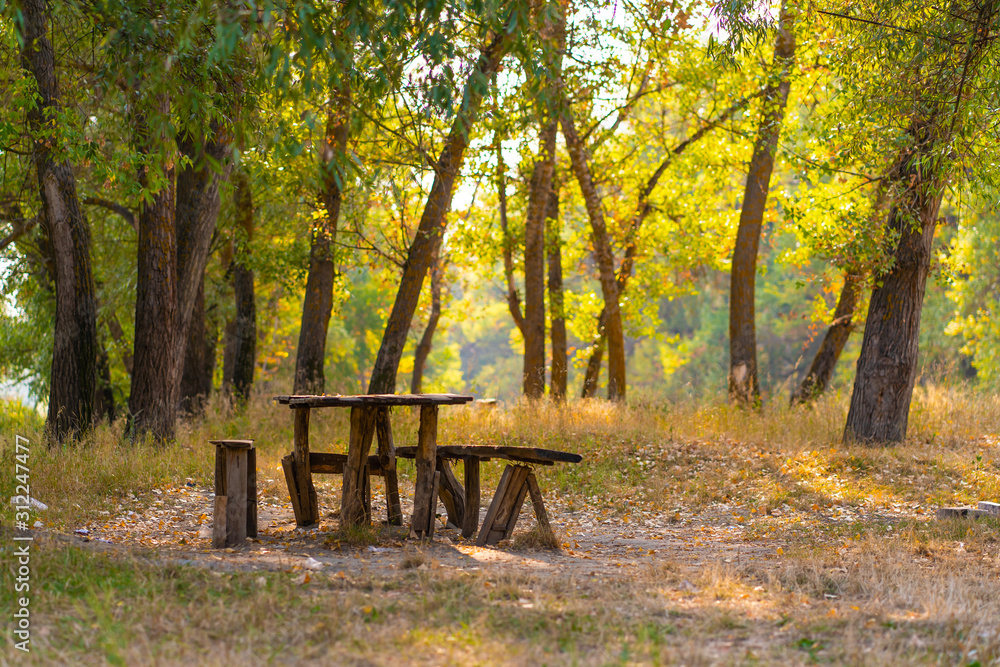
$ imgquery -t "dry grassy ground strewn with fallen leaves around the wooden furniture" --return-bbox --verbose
[0,392,1000,665]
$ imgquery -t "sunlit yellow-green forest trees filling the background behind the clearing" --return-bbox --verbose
[0,0,1000,439]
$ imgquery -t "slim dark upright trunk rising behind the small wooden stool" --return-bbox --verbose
[226,171,257,402]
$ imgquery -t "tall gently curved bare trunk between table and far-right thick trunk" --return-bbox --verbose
[729,0,797,407]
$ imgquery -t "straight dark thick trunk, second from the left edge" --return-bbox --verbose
[128,105,180,440]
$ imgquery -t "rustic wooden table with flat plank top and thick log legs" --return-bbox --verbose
[274,394,472,536]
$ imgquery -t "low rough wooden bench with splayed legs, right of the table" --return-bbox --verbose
[396,445,583,546]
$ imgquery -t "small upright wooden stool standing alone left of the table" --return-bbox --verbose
[209,440,257,549]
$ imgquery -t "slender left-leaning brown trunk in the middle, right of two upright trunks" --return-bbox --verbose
[561,109,625,400]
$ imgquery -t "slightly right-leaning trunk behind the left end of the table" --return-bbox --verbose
[292,85,351,394]
